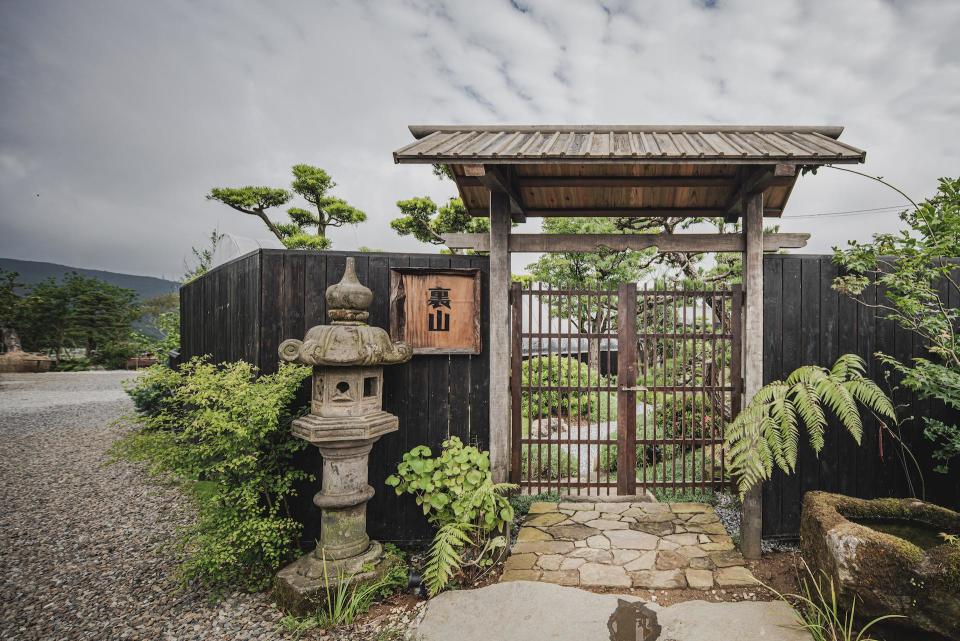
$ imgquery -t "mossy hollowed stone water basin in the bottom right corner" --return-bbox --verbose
[800,492,960,638]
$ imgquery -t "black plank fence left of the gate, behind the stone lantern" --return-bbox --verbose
[180,249,490,547]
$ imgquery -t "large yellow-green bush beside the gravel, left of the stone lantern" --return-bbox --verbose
[114,359,312,590]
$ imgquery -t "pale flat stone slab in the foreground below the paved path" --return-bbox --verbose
[413,581,811,641]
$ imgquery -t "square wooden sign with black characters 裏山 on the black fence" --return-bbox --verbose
[390,267,480,354]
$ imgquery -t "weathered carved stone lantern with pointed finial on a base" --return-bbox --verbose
[276,258,413,613]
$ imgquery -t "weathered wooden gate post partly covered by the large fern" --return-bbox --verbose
[740,192,763,559]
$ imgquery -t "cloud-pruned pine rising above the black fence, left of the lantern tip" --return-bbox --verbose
[207,164,367,249]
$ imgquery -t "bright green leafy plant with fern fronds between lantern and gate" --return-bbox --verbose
[386,437,516,595]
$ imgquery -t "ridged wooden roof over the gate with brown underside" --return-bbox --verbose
[393,125,866,218]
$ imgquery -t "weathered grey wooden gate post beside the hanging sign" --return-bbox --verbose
[486,190,511,483]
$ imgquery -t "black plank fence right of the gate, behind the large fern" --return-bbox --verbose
[763,254,960,537]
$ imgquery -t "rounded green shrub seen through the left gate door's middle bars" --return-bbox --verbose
[520,356,617,421]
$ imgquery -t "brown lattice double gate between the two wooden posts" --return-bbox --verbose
[511,283,742,495]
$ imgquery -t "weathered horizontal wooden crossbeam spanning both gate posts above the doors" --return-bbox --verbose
[443,233,810,254]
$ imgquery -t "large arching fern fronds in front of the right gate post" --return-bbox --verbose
[724,354,896,495]
